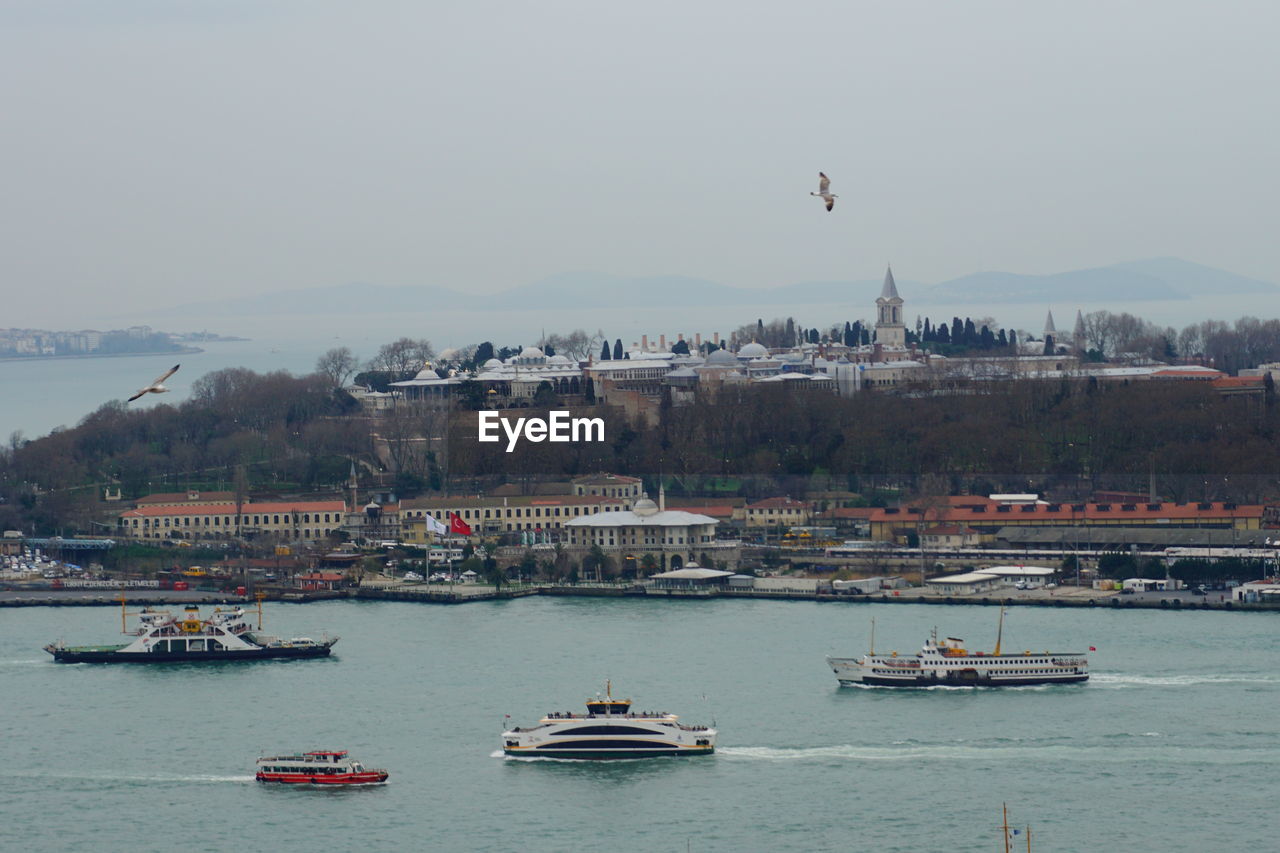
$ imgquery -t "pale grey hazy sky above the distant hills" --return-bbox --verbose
[0,0,1280,325]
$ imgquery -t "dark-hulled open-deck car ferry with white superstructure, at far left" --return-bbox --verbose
[45,597,338,663]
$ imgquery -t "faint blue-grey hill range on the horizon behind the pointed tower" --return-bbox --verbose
[154,257,1280,316]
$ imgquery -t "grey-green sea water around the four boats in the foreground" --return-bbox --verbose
[0,597,1280,853]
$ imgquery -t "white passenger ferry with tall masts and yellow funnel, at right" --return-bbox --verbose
[827,611,1089,686]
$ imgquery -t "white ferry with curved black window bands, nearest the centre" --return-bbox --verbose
[502,685,716,760]
